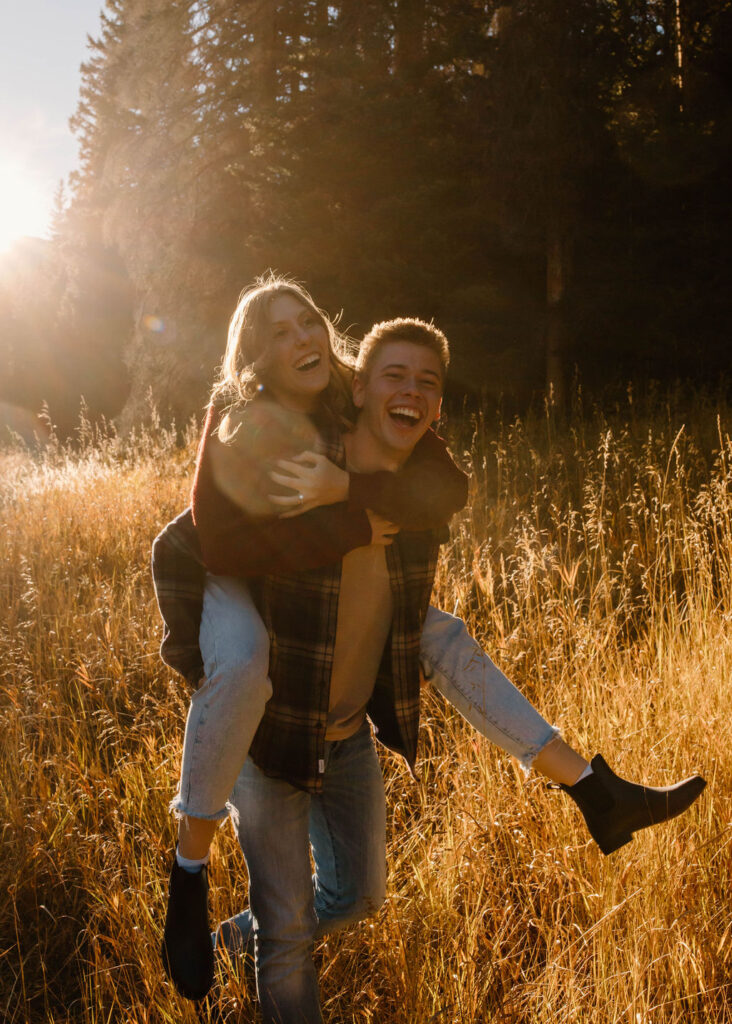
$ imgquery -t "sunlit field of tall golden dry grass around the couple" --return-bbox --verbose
[0,395,732,1024]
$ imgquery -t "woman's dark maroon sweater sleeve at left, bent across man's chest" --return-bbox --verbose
[191,409,371,577]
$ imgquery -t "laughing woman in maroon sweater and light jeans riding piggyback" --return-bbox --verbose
[155,279,703,998]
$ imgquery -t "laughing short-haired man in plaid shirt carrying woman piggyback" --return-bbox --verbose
[222,319,448,1024]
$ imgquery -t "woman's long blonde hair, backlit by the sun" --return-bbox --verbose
[211,271,354,441]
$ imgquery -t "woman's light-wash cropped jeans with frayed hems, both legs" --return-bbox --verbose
[171,575,558,820]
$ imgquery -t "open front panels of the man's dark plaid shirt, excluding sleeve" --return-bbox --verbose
[250,423,444,793]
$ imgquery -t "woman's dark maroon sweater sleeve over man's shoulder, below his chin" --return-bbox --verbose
[349,430,468,530]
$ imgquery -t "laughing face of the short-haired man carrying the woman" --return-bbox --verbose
[353,341,442,464]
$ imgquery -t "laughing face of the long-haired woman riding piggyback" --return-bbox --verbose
[265,293,331,413]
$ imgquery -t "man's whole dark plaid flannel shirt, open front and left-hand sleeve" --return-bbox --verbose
[153,434,446,793]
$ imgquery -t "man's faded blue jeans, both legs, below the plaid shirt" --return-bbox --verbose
[225,723,386,1024]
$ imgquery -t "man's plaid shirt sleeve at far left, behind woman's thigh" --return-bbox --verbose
[152,508,206,686]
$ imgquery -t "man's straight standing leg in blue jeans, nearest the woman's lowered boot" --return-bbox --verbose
[232,760,322,1024]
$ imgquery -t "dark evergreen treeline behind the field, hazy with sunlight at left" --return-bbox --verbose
[0,0,732,436]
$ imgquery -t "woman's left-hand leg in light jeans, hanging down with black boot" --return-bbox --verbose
[163,575,271,999]
